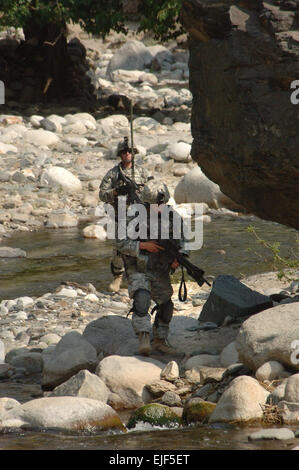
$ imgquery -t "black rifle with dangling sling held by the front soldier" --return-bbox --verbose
[158,239,211,302]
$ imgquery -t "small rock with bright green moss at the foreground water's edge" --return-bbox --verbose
[127,403,181,429]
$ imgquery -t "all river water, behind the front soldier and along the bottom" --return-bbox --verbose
[0,218,299,451]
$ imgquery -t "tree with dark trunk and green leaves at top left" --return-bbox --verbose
[0,0,183,101]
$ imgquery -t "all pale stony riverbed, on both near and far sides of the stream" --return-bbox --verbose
[0,24,299,447]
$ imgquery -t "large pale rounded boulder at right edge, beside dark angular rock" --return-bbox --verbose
[236,302,299,372]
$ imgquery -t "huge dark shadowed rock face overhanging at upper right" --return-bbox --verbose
[181,0,299,229]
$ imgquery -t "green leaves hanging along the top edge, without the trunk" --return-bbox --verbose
[0,0,183,40]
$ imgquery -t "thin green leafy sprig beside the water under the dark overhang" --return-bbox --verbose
[246,225,299,281]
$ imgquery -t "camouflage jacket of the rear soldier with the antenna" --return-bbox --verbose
[99,162,151,205]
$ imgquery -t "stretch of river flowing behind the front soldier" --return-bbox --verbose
[0,218,298,300]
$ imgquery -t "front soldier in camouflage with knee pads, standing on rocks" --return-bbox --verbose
[117,180,186,355]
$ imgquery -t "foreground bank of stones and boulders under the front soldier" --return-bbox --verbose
[0,273,299,446]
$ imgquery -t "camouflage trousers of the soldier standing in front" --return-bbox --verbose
[126,266,173,339]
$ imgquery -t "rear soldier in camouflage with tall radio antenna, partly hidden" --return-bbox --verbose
[99,138,152,292]
